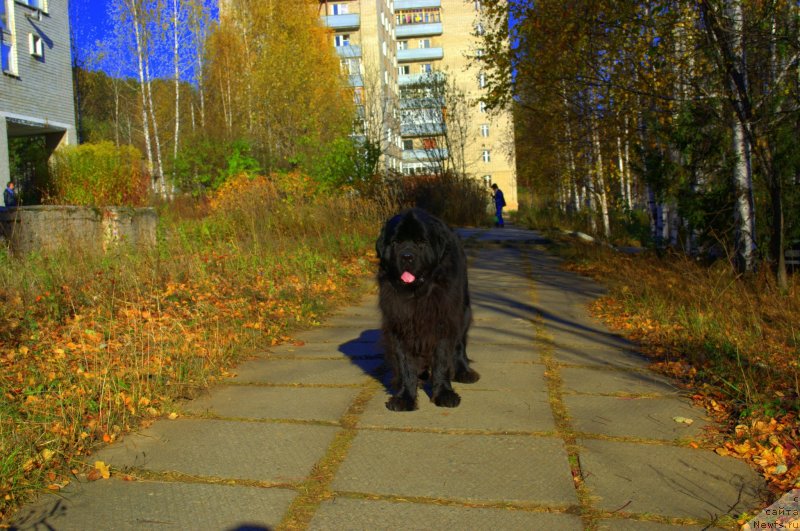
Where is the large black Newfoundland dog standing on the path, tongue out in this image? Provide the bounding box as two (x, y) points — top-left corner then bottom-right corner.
(375, 208), (480, 411)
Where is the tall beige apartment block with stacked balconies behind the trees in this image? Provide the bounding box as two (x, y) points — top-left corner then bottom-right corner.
(320, 0), (518, 209)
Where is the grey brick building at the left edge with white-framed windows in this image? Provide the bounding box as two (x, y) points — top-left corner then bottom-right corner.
(0, 0), (77, 197)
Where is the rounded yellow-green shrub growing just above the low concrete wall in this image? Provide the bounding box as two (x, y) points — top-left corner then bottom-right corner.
(45, 142), (149, 206)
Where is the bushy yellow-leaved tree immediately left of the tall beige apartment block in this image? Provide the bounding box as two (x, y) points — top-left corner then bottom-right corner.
(206, 0), (354, 174)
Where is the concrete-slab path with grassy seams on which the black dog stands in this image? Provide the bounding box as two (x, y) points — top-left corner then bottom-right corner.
(9, 227), (763, 530)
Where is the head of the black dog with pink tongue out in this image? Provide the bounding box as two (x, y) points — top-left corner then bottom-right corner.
(375, 209), (447, 289)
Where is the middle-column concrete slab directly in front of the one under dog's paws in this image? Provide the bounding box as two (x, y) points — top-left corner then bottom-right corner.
(331, 430), (578, 507)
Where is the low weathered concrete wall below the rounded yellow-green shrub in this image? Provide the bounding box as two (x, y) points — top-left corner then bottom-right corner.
(0, 205), (158, 254)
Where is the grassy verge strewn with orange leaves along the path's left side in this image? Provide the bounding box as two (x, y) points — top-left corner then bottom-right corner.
(0, 178), (380, 519)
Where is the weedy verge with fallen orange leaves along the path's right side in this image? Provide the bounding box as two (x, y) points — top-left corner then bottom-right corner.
(555, 238), (800, 508)
